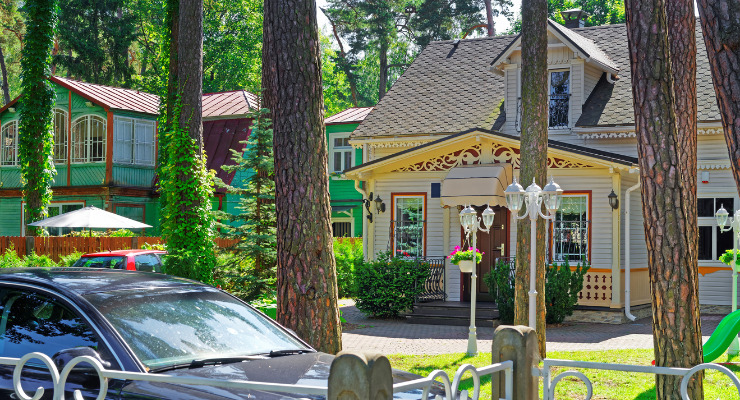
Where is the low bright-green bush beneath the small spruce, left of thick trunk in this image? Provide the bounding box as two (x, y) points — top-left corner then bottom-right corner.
(213, 252), (275, 302)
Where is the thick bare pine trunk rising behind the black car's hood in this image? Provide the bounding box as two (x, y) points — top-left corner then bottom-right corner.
(262, 0), (342, 353)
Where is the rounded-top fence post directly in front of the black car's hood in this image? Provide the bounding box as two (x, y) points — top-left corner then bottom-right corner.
(327, 352), (393, 400)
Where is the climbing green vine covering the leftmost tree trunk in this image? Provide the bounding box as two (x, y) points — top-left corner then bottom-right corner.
(18, 0), (57, 235)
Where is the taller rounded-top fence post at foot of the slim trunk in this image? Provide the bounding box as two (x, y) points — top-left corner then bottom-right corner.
(491, 325), (540, 400)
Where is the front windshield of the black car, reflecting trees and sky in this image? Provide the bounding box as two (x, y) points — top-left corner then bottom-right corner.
(85, 288), (310, 369)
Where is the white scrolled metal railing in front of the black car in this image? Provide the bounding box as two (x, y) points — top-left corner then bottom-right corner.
(0, 353), (514, 400)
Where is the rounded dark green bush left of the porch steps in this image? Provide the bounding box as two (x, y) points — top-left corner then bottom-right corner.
(355, 252), (429, 317)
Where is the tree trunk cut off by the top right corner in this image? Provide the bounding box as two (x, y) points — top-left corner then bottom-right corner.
(697, 0), (740, 195)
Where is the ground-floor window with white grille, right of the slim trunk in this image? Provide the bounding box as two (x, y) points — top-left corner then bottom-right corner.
(552, 195), (590, 265)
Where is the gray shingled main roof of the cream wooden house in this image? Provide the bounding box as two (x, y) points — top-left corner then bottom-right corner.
(352, 23), (720, 137)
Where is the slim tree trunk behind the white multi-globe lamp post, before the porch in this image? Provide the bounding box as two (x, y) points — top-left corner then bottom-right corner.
(514, 0), (549, 357)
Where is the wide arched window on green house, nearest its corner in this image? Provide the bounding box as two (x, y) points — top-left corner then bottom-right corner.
(72, 115), (106, 163)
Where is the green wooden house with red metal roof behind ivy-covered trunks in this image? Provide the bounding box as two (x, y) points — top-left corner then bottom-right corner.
(0, 76), (257, 236)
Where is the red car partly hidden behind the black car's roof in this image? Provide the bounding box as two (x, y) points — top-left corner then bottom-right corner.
(72, 249), (167, 272)
